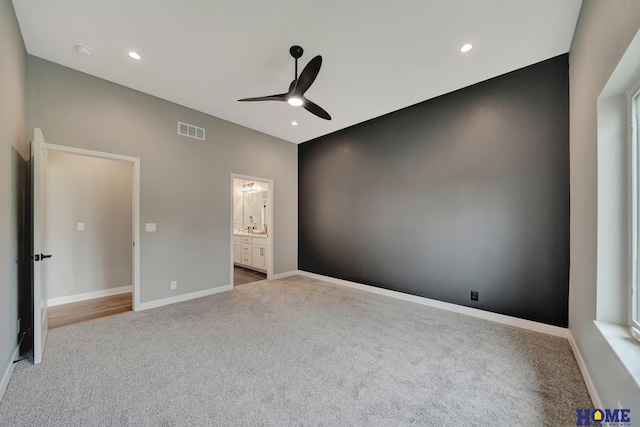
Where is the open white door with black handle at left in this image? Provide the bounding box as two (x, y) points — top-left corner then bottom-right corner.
(31, 128), (51, 364)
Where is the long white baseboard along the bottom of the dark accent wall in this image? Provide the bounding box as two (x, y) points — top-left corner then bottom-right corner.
(294, 270), (569, 338)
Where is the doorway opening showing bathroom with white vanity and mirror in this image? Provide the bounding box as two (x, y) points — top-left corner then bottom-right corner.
(231, 174), (273, 286)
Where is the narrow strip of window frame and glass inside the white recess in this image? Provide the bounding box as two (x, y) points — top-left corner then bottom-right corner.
(629, 80), (640, 341)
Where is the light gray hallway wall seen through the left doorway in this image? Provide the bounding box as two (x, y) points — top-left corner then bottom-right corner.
(47, 151), (133, 298)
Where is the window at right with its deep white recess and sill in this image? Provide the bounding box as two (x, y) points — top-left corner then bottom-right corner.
(596, 26), (640, 390)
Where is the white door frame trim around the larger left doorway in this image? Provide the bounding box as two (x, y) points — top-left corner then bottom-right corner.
(46, 144), (141, 311)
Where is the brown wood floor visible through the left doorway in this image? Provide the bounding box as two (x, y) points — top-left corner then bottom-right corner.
(48, 292), (132, 329)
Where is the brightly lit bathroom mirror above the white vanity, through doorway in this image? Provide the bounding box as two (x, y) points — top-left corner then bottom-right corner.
(233, 178), (269, 234)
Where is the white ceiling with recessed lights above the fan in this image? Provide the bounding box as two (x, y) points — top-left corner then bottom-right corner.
(13, 0), (582, 143)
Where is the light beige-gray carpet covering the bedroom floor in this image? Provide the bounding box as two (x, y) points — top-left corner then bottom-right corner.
(0, 276), (591, 426)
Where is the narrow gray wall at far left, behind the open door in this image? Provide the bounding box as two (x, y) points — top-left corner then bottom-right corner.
(0, 0), (28, 392)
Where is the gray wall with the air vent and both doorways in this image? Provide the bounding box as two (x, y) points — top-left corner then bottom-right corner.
(27, 56), (298, 302)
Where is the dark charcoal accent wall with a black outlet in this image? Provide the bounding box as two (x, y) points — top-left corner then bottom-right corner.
(298, 55), (569, 327)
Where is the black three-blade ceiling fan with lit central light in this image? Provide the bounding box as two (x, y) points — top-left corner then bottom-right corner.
(238, 46), (331, 120)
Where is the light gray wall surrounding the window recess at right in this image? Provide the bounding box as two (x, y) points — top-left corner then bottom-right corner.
(569, 0), (640, 419)
